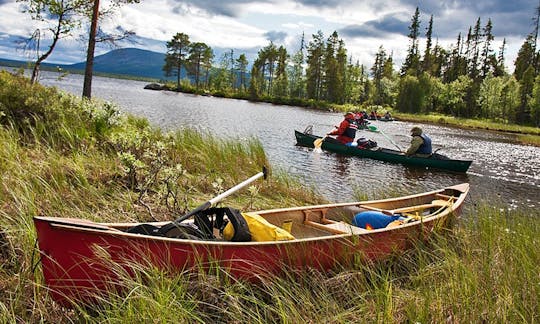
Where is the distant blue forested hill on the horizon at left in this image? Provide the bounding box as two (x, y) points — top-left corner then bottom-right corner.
(0, 48), (177, 80)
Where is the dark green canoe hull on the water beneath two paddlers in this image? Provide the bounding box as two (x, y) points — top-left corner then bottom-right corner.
(294, 130), (472, 172)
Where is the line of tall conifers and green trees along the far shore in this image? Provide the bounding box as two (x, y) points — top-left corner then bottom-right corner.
(163, 8), (540, 127)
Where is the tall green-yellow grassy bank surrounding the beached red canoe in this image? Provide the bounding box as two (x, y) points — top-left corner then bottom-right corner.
(0, 72), (540, 323)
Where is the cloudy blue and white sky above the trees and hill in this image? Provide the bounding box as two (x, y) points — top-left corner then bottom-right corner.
(0, 0), (540, 73)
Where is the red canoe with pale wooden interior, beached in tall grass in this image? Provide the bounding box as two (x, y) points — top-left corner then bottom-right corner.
(34, 183), (469, 306)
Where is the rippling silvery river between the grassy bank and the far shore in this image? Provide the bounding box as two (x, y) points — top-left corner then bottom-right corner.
(28, 72), (540, 209)
